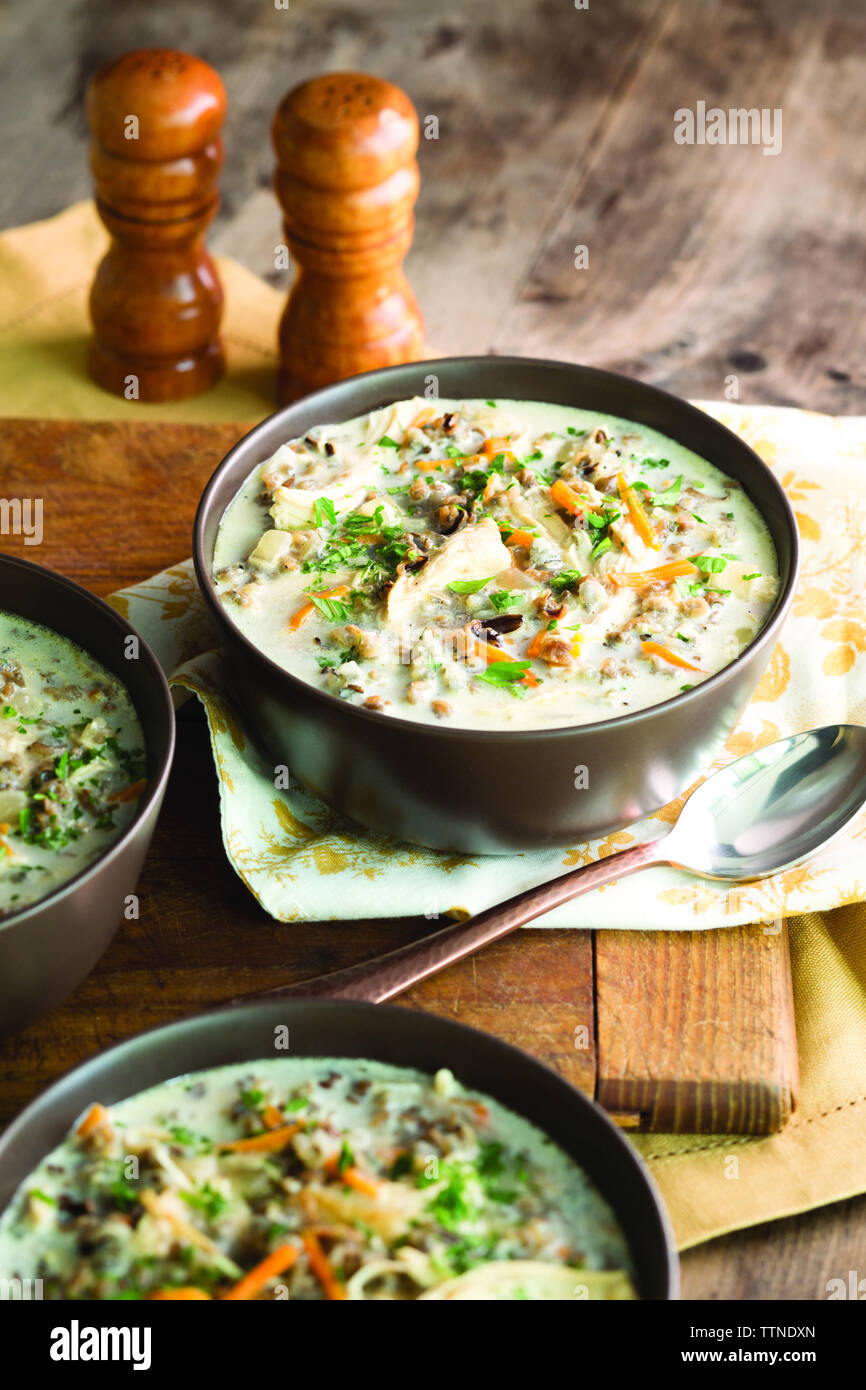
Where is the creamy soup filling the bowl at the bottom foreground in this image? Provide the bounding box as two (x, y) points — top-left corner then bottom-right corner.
(0, 1058), (635, 1301)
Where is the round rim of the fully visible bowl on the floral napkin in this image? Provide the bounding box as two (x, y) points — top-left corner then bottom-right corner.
(193, 354), (801, 745)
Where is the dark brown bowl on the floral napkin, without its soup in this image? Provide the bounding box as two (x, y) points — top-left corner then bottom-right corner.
(195, 357), (799, 853)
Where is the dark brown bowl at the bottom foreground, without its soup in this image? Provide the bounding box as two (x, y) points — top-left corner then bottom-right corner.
(0, 999), (678, 1298)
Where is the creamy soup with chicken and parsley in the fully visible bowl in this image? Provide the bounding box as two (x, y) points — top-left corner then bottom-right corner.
(214, 399), (778, 730)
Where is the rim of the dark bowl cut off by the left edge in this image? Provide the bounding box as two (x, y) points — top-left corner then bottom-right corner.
(0, 550), (177, 937)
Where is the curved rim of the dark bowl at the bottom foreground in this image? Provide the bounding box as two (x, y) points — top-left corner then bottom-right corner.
(0, 995), (680, 1301)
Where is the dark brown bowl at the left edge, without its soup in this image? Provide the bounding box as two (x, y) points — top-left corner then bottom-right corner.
(0, 555), (174, 1034)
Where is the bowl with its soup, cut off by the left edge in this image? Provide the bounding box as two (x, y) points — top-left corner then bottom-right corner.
(0, 556), (174, 1033)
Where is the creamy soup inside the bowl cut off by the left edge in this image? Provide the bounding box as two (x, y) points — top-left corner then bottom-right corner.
(0, 612), (146, 916)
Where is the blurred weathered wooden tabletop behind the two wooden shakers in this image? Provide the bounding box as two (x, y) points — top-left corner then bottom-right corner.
(0, 0), (866, 414)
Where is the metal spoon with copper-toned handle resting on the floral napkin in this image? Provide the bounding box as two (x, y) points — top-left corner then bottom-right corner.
(248, 724), (866, 1004)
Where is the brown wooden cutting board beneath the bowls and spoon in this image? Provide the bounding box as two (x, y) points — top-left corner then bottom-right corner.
(0, 420), (798, 1134)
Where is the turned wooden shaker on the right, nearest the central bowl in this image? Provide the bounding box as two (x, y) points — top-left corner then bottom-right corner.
(272, 72), (424, 400)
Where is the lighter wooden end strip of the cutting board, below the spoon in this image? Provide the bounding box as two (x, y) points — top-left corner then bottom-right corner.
(595, 922), (799, 1134)
